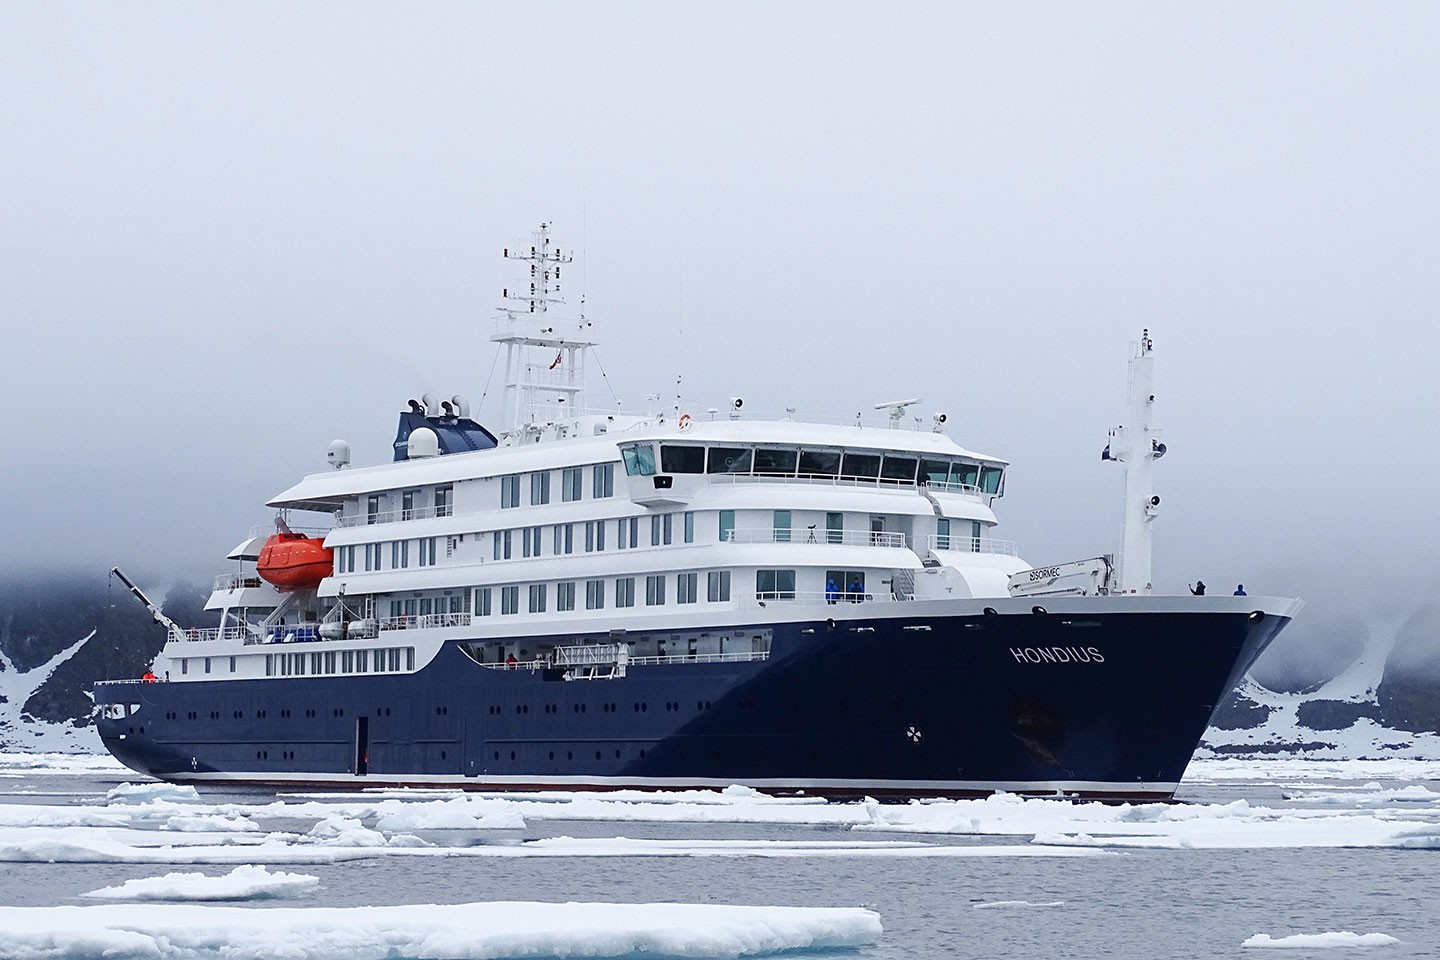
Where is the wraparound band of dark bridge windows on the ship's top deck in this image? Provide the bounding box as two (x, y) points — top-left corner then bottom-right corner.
(621, 443), (1005, 497)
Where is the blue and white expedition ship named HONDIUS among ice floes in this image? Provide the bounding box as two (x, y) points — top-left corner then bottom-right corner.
(95, 226), (1300, 799)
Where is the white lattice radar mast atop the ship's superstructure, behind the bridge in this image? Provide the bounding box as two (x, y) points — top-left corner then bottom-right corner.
(490, 223), (595, 435)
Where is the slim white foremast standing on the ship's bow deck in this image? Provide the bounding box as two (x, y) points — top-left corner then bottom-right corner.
(1100, 330), (1165, 593)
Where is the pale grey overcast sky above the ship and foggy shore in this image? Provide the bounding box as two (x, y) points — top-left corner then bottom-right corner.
(0, 0), (1440, 639)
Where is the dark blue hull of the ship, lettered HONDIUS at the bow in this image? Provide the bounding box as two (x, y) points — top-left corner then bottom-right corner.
(95, 599), (1289, 799)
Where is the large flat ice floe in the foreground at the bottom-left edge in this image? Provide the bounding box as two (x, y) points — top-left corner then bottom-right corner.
(0, 902), (881, 960)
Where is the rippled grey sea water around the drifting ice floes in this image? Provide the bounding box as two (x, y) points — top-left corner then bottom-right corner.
(0, 761), (1440, 960)
